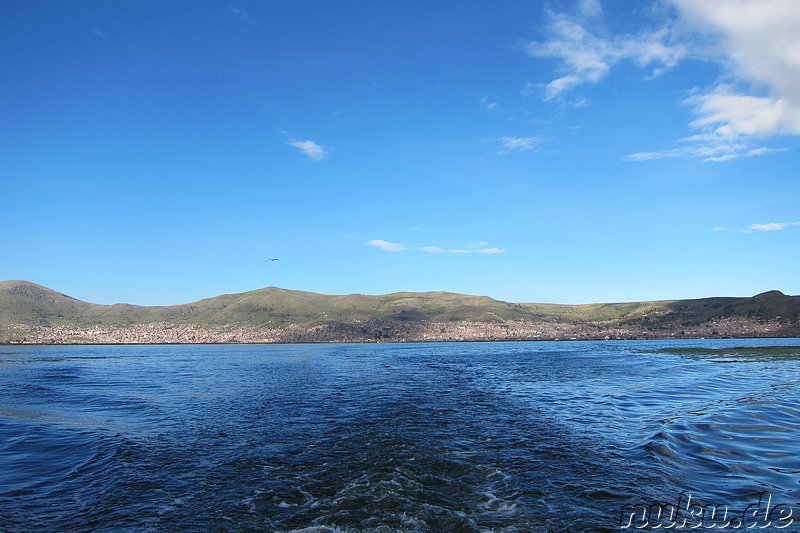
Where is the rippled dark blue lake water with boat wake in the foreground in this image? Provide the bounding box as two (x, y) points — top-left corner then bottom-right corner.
(0, 339), (800, 533)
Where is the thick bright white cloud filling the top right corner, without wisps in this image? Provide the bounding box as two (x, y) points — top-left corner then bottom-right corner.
(660, 0), (800, 161)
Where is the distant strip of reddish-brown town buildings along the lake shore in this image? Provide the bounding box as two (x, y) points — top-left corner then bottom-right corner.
(4, 317), (800, 344)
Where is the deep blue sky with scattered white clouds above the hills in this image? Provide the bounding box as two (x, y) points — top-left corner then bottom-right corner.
(0, 0), (800, 305)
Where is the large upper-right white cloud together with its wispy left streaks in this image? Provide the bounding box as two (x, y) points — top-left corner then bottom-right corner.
(526, 0), (800, 162)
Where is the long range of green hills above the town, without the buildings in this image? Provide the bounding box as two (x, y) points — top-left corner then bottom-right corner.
(0, 281), (800, 328)
